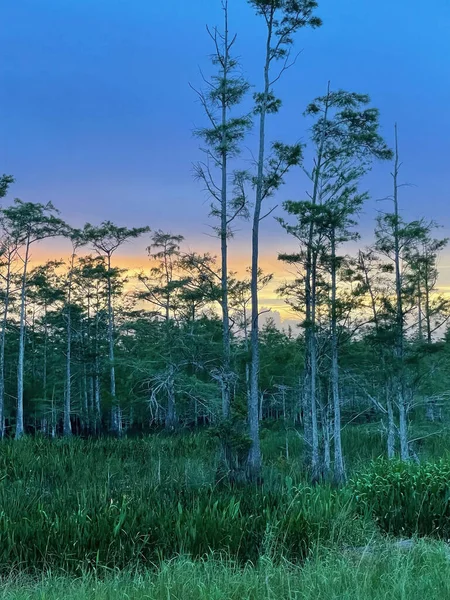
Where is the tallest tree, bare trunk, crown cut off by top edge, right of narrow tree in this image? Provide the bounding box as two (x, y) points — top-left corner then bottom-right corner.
(248, 0), (322, 480)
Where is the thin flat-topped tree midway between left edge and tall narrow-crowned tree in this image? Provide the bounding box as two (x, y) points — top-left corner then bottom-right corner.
(83, 221), (149, 436)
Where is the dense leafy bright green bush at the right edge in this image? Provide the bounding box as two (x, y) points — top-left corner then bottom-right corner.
(350, 460), (450, 539)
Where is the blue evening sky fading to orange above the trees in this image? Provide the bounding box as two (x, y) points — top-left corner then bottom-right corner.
(0, 0), (450, 318)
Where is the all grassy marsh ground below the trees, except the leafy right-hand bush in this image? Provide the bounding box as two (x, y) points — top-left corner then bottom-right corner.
(0, 423), (450, 600)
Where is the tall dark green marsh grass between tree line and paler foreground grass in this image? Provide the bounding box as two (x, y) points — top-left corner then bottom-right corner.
(0, 424), (450, 584)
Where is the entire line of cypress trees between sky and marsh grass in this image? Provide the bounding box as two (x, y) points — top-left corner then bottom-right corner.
(0, 0), (450, 484)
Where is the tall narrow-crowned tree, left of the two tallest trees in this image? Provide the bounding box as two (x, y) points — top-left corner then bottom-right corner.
(192, 0), (252, 432)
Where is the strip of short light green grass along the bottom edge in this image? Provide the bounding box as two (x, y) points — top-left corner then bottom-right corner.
(0, 542), (450, 600)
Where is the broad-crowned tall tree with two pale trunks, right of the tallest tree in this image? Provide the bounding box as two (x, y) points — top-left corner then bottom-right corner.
(280, 85), (391, 484)
